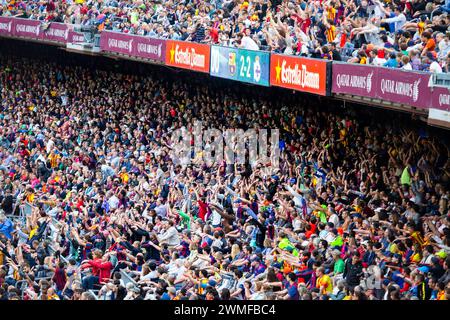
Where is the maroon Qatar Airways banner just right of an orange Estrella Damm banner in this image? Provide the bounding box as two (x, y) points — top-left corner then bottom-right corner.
(332, 63), (432, 108)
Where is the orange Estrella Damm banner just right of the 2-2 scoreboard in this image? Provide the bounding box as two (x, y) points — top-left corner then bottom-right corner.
(270, 54), (330, 95)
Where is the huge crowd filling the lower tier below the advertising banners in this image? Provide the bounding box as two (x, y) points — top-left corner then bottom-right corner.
(0, 51), (450, 300)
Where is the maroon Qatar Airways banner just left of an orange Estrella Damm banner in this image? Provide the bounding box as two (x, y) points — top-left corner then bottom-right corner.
(100, 31), (166, 62)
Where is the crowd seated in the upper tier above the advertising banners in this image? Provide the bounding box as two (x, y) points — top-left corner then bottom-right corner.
(0, 0), (450, 72)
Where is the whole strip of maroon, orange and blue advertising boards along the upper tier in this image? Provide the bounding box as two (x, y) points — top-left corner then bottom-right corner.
(0, 17), (450, 111)
